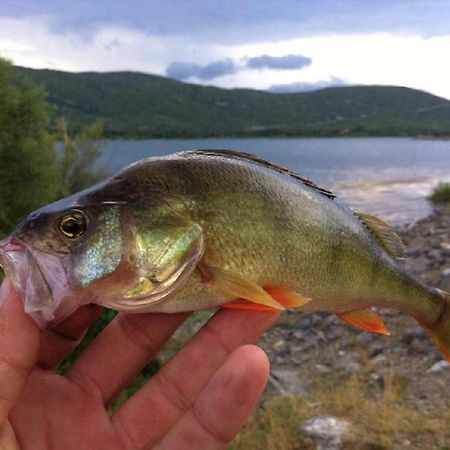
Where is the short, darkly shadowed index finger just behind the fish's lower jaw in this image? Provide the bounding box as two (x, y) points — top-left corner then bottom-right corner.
(38, 304), (102, 369)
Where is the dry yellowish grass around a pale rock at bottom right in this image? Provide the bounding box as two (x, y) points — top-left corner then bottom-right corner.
(229, 370), (450, 450)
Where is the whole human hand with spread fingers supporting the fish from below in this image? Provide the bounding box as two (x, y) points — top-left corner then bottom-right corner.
(0, 280), (277, 450)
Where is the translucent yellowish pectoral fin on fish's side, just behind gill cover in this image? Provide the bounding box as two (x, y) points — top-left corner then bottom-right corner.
(197, 263), (285, 309)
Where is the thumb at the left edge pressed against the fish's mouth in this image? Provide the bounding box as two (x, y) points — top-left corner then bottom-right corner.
(0, 279), (39, 424)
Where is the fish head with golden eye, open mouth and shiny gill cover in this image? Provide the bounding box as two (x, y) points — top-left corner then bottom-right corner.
(0, 200), (203, 326)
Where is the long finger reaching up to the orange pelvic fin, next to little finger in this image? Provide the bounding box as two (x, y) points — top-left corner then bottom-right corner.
(113, 310), (278, 448)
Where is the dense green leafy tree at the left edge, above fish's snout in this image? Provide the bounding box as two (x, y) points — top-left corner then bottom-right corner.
(0, 58), (58, 236)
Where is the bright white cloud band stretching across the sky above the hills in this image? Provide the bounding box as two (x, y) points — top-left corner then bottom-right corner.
(0, 17), (450, 99)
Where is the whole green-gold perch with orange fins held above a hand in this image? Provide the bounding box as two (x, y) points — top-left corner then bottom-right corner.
(0, 150), (450, 361)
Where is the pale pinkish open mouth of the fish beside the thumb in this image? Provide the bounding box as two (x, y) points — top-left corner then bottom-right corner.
(0, 237), (74, 327)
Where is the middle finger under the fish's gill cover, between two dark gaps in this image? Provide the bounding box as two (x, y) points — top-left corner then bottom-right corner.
(66, 313), (187, 404)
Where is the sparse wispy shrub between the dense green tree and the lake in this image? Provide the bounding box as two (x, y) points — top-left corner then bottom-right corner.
(56, 119), (106, 197)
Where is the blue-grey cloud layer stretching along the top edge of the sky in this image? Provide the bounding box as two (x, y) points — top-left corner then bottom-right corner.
(0, 0), (450, 43)
